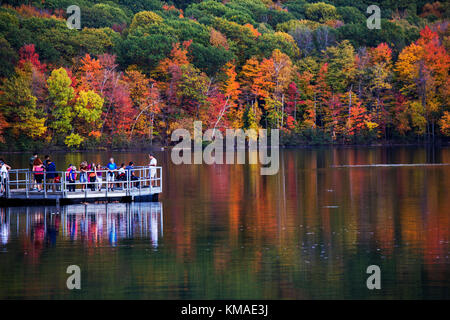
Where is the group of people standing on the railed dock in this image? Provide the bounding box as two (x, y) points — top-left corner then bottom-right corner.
(0, 153), (157, 193)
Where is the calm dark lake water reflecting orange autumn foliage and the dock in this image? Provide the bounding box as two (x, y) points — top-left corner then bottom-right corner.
(0, 147), (450, 299)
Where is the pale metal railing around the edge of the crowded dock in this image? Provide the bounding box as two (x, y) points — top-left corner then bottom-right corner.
(2, 166), (162, 198)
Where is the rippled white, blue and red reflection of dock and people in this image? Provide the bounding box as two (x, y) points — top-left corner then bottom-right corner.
(0, 202), (163, 248)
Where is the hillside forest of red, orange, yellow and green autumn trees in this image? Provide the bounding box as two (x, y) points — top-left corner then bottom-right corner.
(0, 0), (450, 151)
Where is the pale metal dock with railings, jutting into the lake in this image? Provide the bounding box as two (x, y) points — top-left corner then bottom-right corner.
(0, 167), (162, 206)
